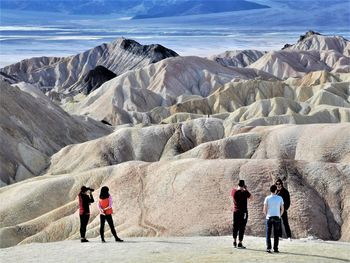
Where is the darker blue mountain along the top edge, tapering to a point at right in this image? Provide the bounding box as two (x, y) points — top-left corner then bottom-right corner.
(1, 0), (268, 19)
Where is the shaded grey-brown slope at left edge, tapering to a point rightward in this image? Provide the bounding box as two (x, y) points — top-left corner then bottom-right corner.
(0, 82), (111, 186)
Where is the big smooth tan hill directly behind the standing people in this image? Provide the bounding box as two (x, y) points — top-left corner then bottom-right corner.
(0, 159), (350, 250)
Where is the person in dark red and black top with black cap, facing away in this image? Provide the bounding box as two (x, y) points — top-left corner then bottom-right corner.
(231, 180), (252, 248)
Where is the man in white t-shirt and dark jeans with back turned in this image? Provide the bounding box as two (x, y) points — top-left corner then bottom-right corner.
(264, 185), (284, 253)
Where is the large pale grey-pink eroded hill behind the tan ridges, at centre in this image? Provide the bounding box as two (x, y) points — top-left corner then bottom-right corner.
(71, 57), (274, 125)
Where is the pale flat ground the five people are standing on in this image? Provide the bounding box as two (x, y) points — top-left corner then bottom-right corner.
(0, 236), (350, 263)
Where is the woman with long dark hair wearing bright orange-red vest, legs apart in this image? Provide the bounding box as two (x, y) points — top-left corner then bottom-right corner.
(98, 186), (123, 243)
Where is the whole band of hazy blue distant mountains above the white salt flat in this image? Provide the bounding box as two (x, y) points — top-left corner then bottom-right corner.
(0, 0), (350, 31)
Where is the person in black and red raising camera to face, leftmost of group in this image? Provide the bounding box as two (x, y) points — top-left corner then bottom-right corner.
(78, 185), (94, 242)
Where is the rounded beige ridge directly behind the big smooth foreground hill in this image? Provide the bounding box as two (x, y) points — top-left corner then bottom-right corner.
(48, 122), (350, 174)
